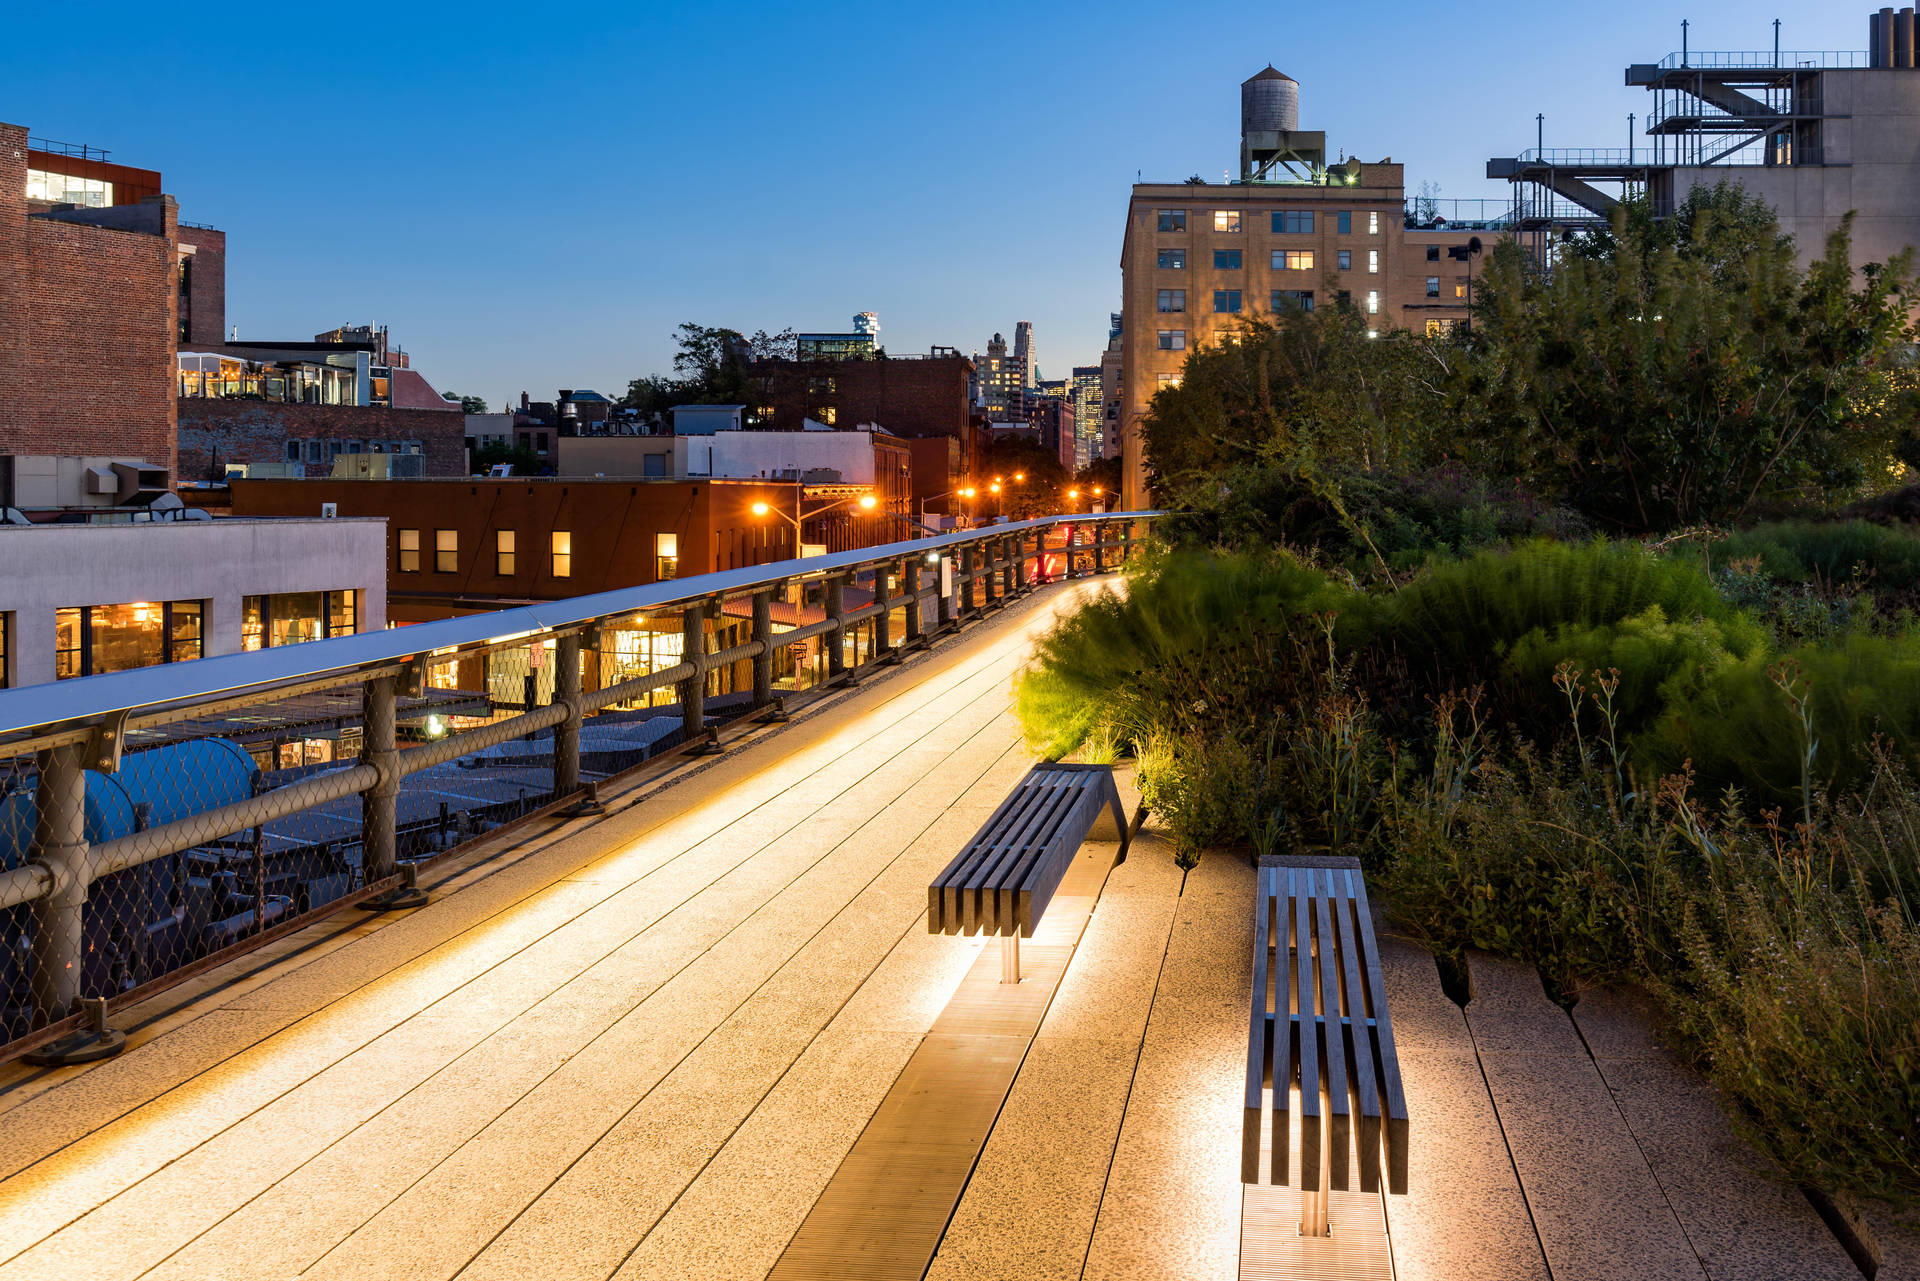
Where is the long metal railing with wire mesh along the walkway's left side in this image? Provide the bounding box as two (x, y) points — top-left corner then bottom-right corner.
(0, 513), (1158, 1060)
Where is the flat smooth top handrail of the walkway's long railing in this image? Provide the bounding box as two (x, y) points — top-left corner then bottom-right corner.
(0, 511), (1160, 753)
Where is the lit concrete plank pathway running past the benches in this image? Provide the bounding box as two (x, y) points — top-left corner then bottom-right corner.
(0, 586), (1889, 1281)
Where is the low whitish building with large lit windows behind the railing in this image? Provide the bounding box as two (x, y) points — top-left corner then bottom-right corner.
(0, 507), (386, 688)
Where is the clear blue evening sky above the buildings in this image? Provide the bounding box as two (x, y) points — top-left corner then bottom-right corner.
(0, 0), (1876, 407)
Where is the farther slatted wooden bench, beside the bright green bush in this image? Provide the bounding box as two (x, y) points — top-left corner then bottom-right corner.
(927, 764), (1127, 983)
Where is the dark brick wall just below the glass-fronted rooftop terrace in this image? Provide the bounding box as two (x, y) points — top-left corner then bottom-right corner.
(179, 396), (467, 480)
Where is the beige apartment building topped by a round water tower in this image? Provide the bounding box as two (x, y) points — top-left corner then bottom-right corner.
(1119, 67), (1501, 509)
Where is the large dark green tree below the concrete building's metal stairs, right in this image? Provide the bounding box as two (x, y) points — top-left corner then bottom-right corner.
(1455, 204), (1920, 534)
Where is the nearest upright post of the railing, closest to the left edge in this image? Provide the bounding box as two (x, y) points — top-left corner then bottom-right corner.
(33, 743), (92, 1024)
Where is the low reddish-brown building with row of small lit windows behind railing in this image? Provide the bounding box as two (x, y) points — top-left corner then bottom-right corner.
(230, 478), (797, 622)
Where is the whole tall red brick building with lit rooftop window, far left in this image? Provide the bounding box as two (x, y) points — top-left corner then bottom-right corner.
(0, 123), (192, 507)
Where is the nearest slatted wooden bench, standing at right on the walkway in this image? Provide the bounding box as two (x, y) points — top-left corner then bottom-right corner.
(1240, 857), (1407, 1237)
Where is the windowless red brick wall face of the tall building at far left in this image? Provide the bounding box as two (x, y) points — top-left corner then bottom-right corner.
(0, 125), (177, 472)
